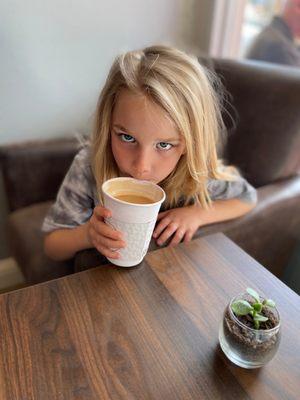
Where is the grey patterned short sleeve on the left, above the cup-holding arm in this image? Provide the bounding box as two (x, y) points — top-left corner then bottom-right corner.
(42, 146), (95, 233)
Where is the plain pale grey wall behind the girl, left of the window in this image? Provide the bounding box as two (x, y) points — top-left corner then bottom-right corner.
(0, 0), (213, 256)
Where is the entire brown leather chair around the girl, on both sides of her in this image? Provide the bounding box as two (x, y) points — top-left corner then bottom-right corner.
(0, 59), (300, 283)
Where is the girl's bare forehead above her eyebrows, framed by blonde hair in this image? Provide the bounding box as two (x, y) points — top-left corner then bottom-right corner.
(112, 89), (180, 137)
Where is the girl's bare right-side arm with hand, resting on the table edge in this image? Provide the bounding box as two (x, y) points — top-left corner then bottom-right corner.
(153, 199), (255, 246)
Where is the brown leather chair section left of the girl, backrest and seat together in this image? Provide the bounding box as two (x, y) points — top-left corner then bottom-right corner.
(0, 138), (78, 284)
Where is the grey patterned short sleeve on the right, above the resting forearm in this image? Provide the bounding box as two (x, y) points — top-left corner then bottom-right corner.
(207, 176), (257, 204)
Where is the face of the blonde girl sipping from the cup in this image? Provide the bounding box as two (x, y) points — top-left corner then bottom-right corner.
(111, 89), (185, 183)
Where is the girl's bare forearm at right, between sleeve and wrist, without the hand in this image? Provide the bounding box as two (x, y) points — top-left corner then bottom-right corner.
(200, 199), (255, 225)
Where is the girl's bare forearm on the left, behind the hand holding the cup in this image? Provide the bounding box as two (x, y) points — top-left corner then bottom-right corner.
(44, 224), (92, 261)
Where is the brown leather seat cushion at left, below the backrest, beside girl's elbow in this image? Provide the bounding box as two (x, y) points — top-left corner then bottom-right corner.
(7, 201), (73, 284)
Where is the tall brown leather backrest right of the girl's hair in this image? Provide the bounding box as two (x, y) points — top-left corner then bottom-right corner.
(200, 59), (300, 187)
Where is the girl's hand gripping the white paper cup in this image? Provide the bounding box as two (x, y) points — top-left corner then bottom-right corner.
(87, 206), (126, 259)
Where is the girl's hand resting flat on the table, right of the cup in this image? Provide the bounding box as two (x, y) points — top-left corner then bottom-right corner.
(153, 206), (203, 246)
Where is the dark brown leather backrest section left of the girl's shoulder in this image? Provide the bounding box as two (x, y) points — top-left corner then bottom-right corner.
(0, 138), (79, 211)
